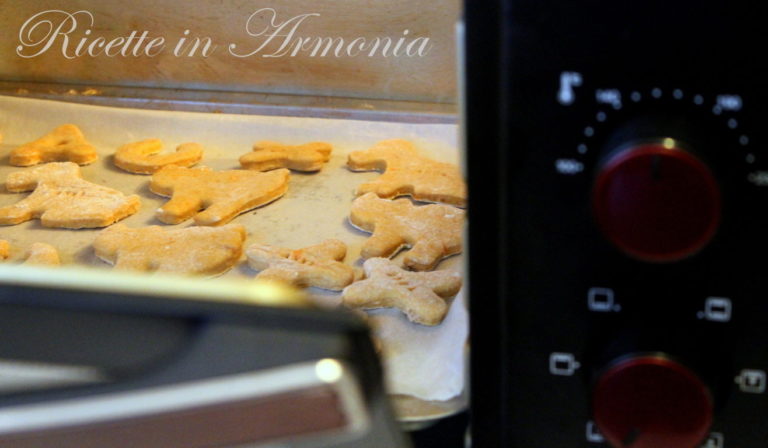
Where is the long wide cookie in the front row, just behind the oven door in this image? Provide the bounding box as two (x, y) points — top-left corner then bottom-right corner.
(93, 224), (246, 275)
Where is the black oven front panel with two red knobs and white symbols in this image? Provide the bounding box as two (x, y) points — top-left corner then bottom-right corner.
(464, 0), (768, 448)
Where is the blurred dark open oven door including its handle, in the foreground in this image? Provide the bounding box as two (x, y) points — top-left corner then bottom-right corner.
(0, 267), (381, 448)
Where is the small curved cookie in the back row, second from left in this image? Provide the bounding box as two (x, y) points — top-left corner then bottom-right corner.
(114, 138), (203, 174)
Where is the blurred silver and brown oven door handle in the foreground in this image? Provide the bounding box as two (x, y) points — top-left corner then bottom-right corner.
(0, 359), (370, 448)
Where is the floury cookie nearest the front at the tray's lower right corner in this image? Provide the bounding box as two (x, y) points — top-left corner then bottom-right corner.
(342, 258), (461, 325)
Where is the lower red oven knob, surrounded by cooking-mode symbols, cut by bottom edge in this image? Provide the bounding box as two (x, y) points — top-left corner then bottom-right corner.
(592, 355), (713, 448)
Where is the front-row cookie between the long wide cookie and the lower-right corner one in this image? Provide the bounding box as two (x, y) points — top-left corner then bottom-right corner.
(245, 240), (355, 291)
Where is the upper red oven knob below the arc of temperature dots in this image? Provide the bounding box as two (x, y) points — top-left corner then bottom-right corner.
(592, 139), (721, 262)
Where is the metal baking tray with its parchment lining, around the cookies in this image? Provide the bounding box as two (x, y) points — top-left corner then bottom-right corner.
(0, 88), (468, 428)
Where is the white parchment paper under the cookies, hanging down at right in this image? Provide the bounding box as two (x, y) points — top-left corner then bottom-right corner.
(0, 97), (468, 400)
